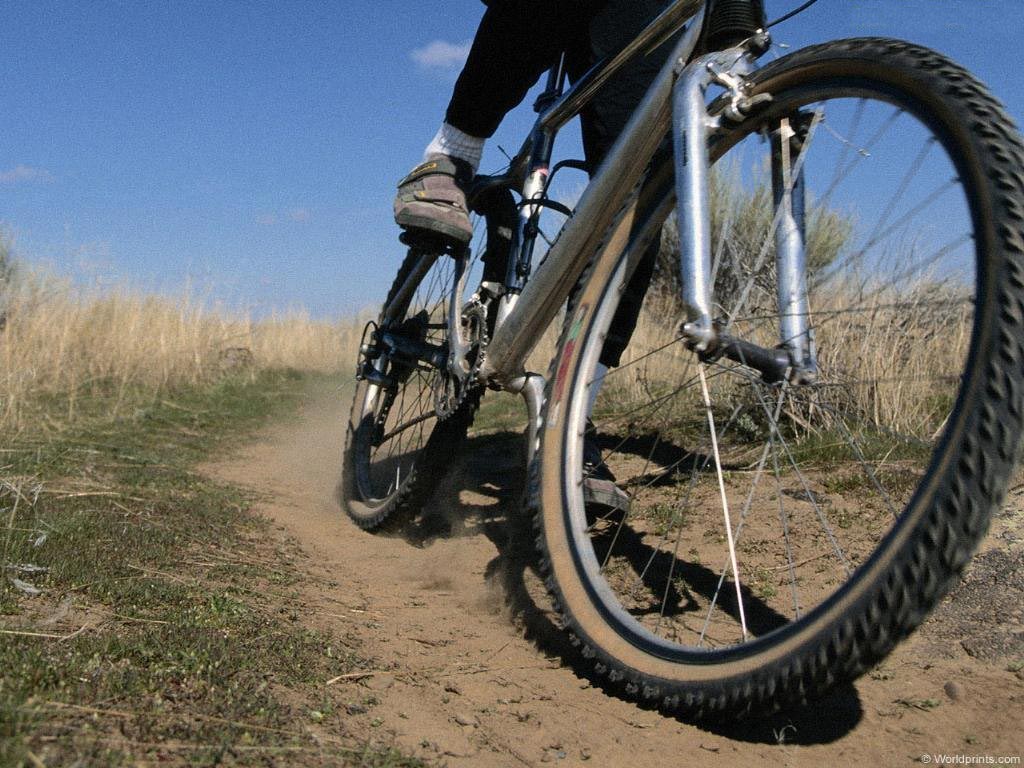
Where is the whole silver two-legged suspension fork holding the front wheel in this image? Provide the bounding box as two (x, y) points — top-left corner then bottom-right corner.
(672, 34), (816, 382)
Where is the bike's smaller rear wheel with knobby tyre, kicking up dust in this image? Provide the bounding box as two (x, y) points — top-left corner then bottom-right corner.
(340, 248), (480, 529)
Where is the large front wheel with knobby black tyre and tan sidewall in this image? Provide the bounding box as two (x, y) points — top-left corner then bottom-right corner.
(531, 39), (1024, 718)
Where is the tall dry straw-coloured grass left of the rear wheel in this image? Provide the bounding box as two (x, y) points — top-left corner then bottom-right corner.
(0, 272), (361, 430)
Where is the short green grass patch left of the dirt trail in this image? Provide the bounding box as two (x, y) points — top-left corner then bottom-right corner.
(0, 371), (422, 766)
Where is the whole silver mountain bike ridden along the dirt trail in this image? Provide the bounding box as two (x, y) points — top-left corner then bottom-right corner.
(342, 0), (1024, 719)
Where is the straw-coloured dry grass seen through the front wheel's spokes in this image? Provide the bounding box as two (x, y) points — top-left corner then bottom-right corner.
(598, 281), (973, 441)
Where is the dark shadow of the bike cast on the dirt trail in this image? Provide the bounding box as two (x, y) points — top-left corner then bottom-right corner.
(401, 432), (864, 745)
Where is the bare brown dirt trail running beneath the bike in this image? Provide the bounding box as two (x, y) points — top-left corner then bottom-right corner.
(211, 392), (1024, 766)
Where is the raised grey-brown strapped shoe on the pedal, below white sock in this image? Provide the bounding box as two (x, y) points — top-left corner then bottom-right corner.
(394, 155), (473, 245)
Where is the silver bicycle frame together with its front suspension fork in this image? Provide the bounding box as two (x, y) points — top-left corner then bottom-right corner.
(384, 0), (802, 434)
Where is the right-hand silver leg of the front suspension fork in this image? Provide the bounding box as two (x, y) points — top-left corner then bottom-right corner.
(771, 118), (816, 379)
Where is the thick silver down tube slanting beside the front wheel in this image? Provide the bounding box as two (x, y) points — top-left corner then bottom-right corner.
(480, 7), (703, 385)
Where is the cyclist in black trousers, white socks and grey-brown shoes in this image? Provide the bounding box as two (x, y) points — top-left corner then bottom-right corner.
(394, 0), (673, 507)
